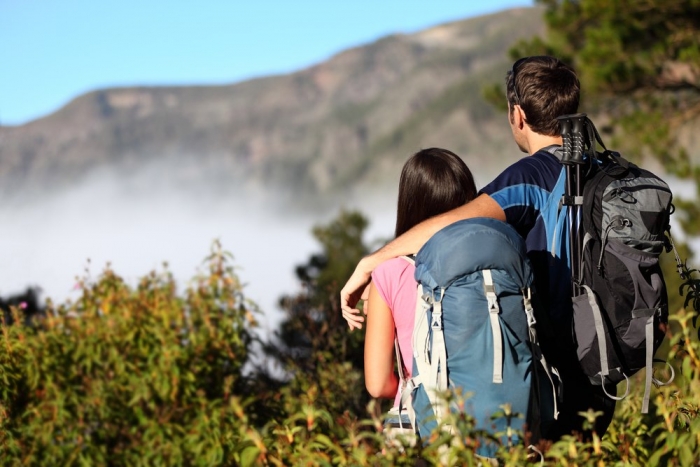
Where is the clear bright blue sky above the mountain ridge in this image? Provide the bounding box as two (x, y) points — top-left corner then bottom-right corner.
(0, 0), (534, 125)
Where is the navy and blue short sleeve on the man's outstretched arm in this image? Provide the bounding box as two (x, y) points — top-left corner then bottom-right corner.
(479, 156), (549, 236)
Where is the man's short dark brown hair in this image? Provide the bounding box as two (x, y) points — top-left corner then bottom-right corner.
(506, 56), (581, 136)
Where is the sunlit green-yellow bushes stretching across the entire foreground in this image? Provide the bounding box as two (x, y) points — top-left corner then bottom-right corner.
(0, 241), (700, 466)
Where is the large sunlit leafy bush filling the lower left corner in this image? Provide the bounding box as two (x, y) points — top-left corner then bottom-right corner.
(0, 244), (255, 465)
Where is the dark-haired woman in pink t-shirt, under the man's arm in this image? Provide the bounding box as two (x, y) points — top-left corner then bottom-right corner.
(365, 148), (476, 427)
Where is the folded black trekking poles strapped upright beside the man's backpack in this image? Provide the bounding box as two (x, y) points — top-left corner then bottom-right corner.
(557, 113), (587, 297)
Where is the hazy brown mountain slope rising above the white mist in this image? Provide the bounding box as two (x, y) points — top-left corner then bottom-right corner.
(0, 8), (544, 207)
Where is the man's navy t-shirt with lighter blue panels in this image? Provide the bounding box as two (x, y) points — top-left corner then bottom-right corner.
(479, 146), (572, 331)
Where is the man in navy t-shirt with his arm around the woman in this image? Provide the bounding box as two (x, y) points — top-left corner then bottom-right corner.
(340, 56), (615, 439)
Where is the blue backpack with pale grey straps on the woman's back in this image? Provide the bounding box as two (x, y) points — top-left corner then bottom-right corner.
(402, 218), (557, 457)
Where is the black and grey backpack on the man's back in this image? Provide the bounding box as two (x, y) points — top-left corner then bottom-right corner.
(562, 115), (673, 413)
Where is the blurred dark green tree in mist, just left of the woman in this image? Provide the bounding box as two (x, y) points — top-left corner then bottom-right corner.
(266, 211), (368, 416)
